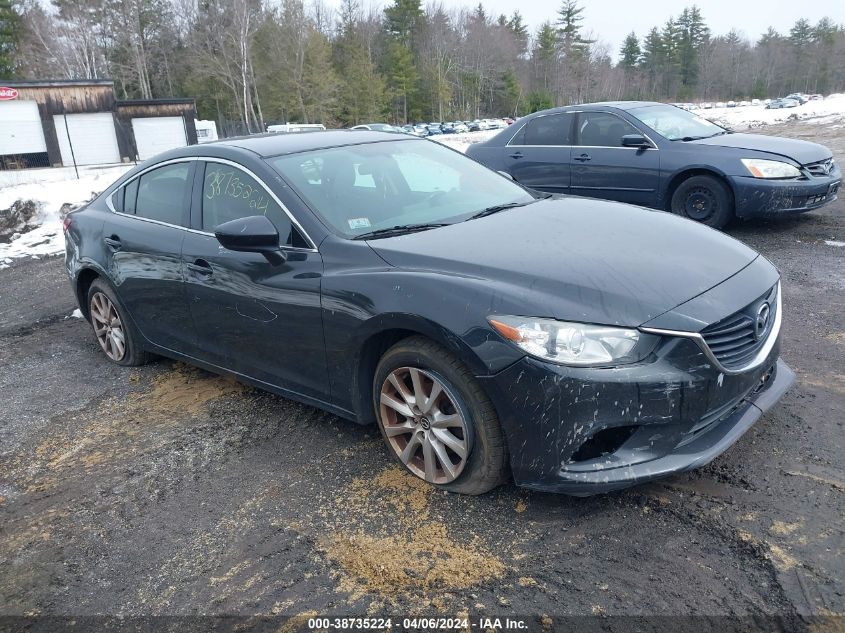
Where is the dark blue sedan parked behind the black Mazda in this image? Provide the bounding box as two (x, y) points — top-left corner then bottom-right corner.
(467, 101), (842, 228)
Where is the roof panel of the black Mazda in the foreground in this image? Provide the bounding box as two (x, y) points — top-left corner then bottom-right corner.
(197, 130), (416, 158)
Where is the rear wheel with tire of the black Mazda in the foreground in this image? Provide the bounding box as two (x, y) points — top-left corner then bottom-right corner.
(88, 279), (150, 367)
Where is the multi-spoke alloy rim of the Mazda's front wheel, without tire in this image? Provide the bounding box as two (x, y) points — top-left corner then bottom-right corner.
(379, 367), (472, 484)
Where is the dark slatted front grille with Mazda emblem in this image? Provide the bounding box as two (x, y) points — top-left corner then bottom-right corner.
(701, 284), (778, 369)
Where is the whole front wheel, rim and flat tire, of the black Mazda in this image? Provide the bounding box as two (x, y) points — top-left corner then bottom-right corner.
(373, 336), (508, 495)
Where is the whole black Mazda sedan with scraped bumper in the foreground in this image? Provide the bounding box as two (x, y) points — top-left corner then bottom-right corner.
(65, 131), (793, 495)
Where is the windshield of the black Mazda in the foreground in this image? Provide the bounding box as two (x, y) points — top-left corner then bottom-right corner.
(268, 139), (534, 239)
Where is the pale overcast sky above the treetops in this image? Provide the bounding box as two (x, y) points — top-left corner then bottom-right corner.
(327, 0), (845, 58)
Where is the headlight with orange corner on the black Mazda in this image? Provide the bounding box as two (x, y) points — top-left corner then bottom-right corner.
(488, 315), (659, 367)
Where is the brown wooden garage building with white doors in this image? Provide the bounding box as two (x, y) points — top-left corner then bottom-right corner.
(0, 79), (197, 169)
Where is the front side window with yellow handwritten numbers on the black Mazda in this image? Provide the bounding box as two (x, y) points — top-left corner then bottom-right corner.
(202, 163), (304, 246)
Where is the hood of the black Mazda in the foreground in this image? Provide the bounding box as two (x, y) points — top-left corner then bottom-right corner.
(369, 197), (762, 327)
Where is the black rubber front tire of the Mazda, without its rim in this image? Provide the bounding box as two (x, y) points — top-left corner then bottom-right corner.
(373, 336), (509, 495)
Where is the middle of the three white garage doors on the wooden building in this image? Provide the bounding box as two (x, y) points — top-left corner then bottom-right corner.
(53, 112), (120, 166)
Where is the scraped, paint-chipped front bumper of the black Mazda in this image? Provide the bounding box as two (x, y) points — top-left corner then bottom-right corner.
(479, 338), (795, 496)
